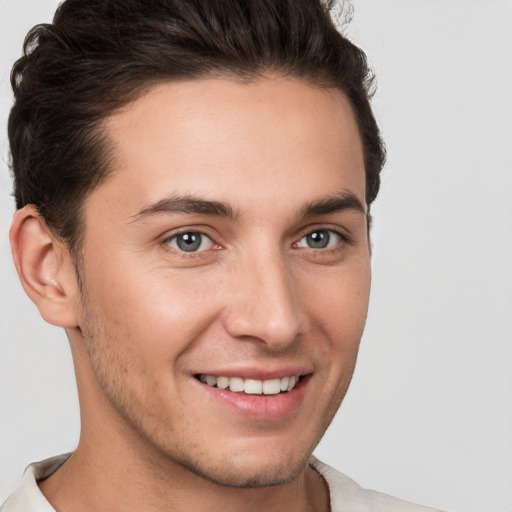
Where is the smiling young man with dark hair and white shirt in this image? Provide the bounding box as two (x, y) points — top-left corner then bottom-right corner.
(2, 0), (444, 512)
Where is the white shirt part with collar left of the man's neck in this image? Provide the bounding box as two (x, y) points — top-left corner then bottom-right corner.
(0, 454), (69, 512)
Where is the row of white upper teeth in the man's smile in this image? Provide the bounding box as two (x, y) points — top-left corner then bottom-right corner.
(198, 374), (299, 395)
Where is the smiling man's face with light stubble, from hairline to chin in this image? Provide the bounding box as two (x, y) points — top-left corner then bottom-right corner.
(70, 79), (370, 486)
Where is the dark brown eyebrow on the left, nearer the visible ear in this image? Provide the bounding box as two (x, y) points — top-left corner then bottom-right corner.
(129, 195), (239, 222)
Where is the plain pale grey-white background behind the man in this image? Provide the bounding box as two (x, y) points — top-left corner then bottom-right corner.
(0, 0), (512, 512)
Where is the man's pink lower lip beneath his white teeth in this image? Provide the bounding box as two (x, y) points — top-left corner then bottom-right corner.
(194, 375), (311, 420)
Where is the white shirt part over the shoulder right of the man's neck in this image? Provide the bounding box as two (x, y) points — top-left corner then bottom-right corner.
(310, 457), (441, 512)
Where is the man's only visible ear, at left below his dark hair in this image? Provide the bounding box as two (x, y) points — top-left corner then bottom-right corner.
(10, 205), (79, 328)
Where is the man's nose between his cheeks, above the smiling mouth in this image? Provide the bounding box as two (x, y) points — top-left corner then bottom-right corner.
(225, 250), (307, 350)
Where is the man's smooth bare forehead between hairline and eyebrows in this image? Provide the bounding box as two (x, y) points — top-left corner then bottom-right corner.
(93, 78), (365, 215)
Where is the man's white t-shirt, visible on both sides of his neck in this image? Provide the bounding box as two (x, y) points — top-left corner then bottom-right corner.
(0, 454), (441, 512)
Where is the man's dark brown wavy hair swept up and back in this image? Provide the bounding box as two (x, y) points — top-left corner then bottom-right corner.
(8, 0), (385, 254)
